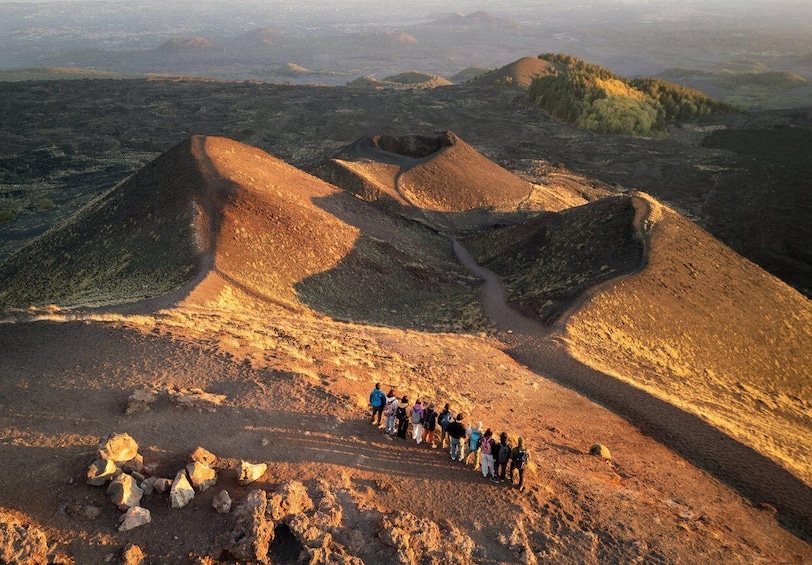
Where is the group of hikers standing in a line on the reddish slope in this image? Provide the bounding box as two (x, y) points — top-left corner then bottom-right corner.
(369, 383), (530, 491)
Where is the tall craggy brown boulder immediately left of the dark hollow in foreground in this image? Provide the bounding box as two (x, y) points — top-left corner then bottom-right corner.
(225, 489), (274, 563)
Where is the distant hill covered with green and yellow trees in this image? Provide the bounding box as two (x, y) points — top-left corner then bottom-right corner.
(529, 53), (734, 135)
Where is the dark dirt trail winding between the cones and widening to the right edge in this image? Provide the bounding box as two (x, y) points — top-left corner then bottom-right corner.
(454, 241), (812, 541)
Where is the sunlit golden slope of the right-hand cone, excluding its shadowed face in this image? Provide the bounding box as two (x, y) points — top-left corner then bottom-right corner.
(564, 198), (812, 484)
